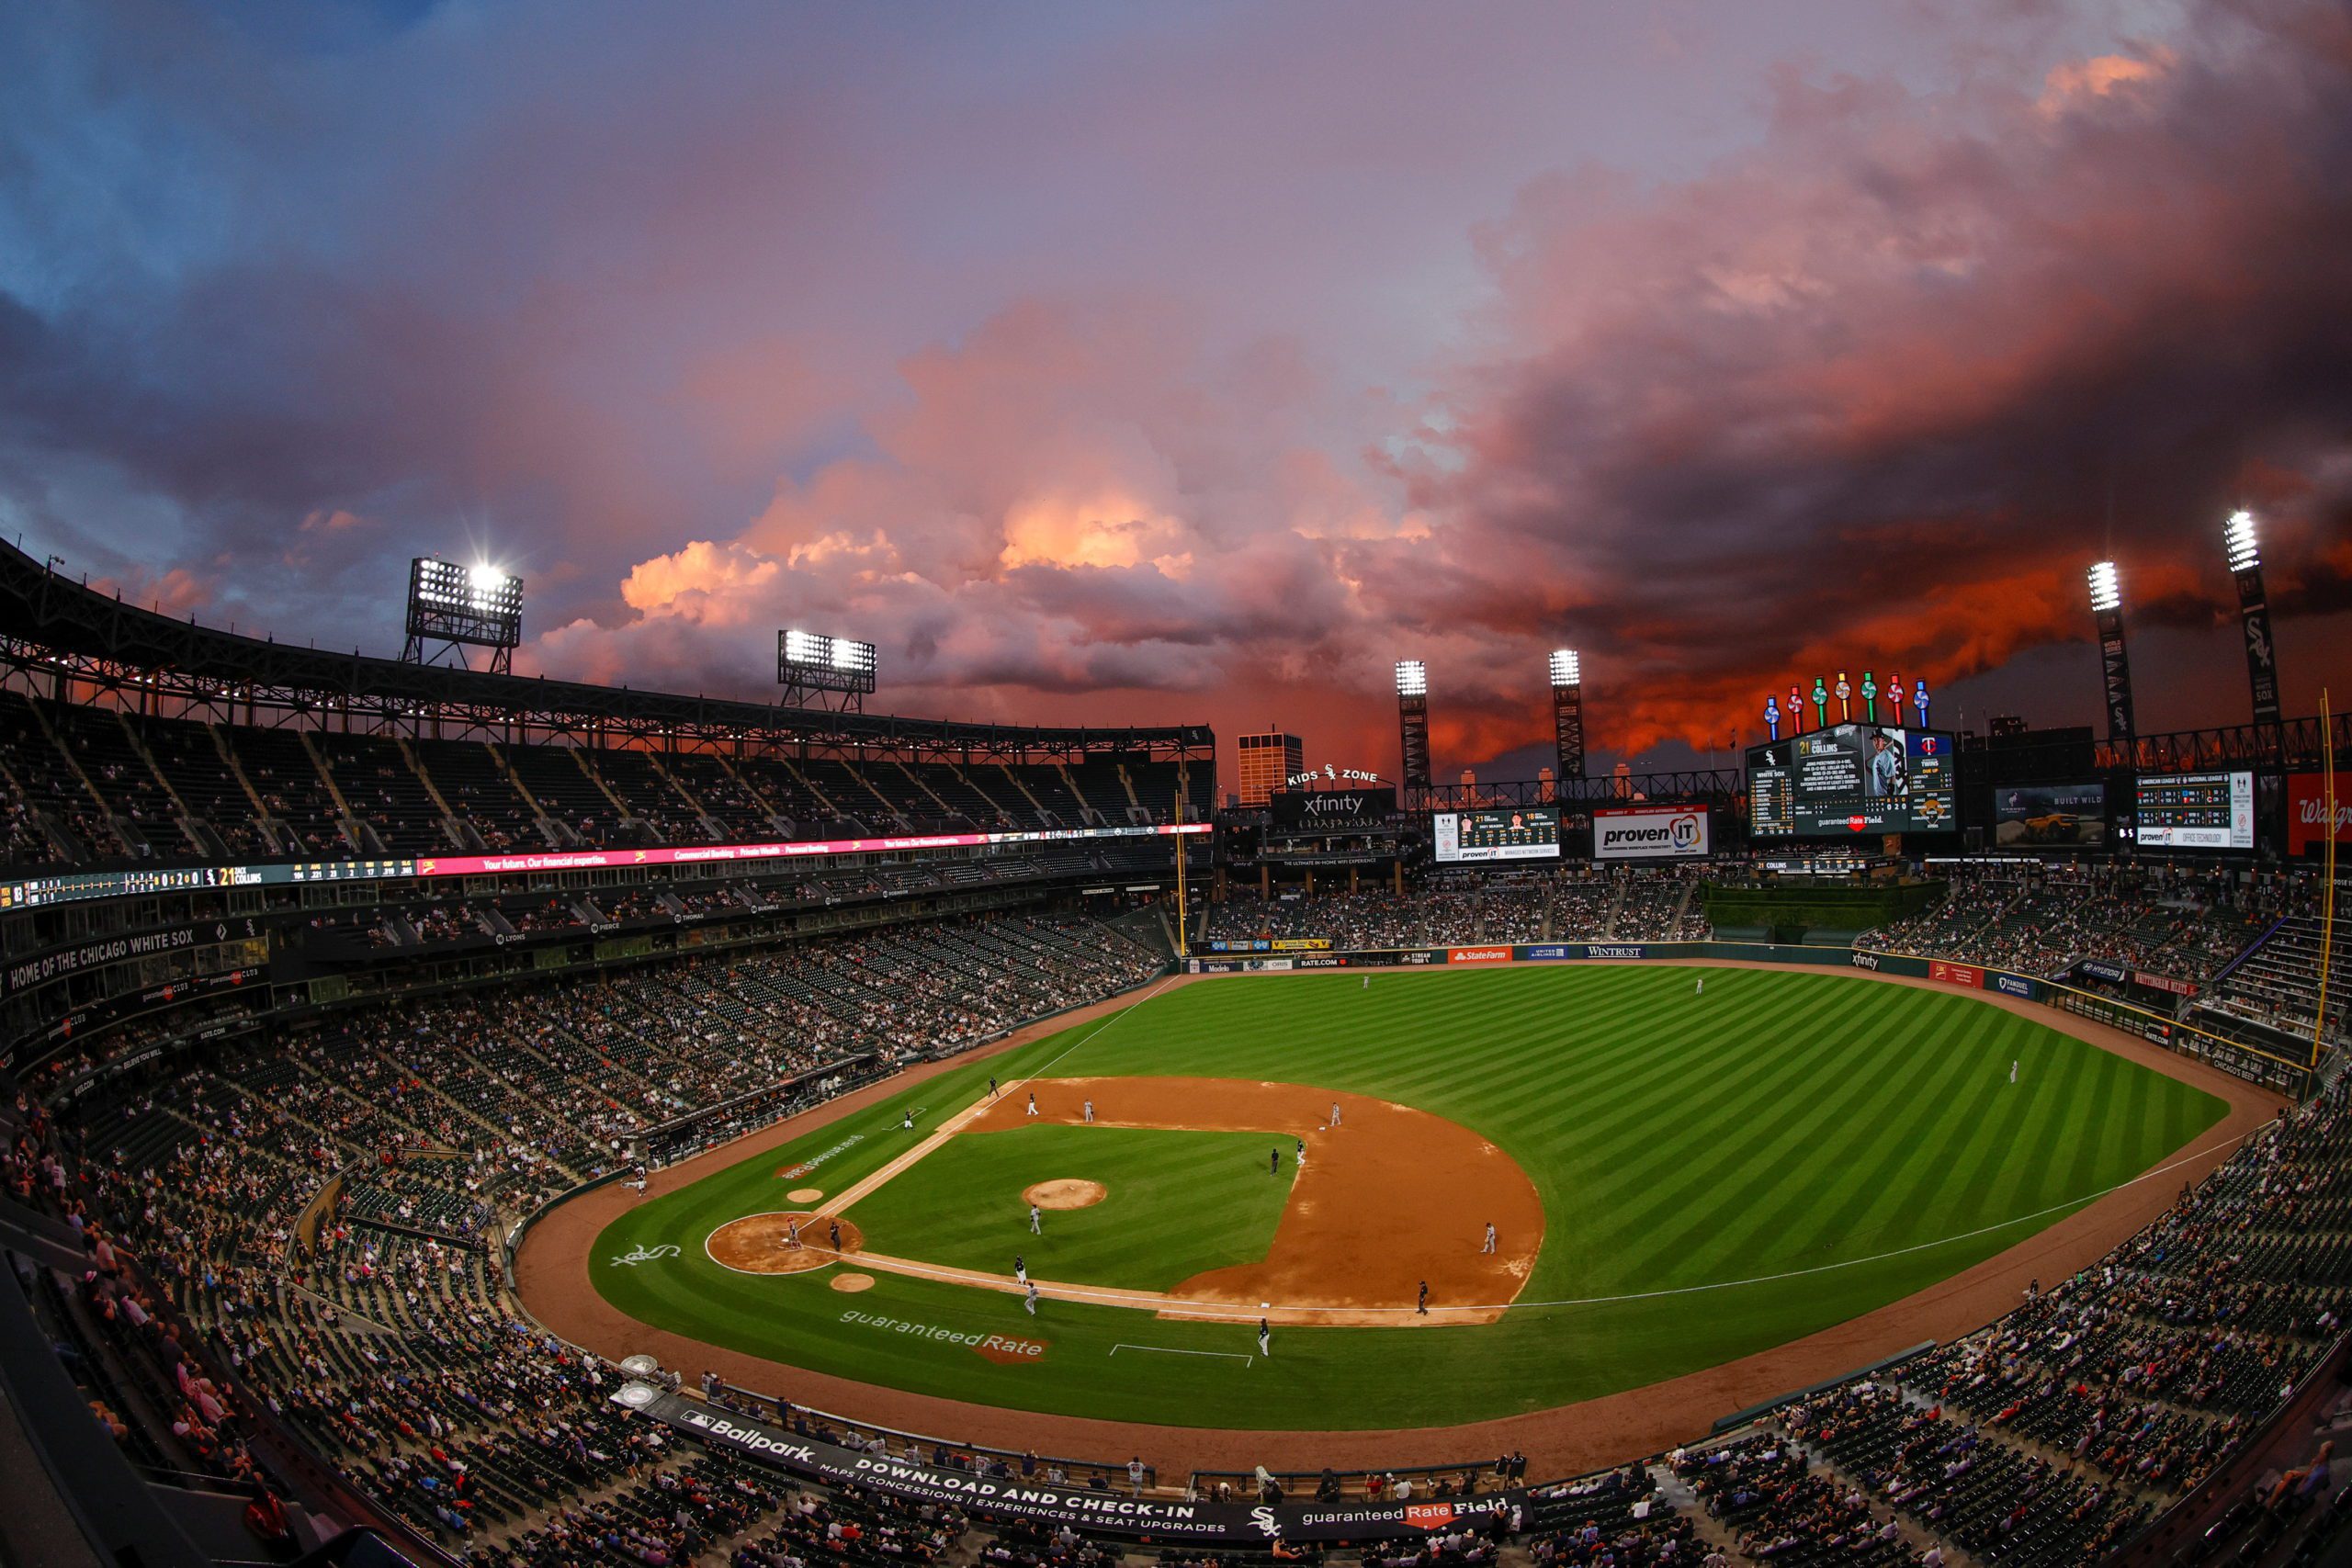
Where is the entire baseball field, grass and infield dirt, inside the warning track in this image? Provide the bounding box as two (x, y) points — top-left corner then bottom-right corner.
(591, 966), (2227, 1429)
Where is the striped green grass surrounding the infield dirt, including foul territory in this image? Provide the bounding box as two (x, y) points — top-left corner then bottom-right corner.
(591, 966), (2225, 1427)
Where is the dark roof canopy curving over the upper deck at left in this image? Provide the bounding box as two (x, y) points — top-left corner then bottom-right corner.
(0, 541), (1216, 760)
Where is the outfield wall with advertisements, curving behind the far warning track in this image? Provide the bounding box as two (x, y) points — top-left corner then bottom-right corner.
(1183, 938), (2312, 1098)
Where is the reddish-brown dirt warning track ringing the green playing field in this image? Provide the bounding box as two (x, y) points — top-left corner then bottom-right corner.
(515, 959), (2281, 1476)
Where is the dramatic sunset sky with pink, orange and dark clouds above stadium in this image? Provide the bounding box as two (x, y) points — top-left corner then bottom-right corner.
(0, 0), (2352, 776)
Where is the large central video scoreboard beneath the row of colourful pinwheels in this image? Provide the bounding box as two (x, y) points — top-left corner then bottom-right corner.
(1747, 724), (1957, 840)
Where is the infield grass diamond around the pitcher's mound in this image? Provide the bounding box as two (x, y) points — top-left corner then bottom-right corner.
(852, 1126), (1294, 1291)
